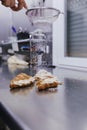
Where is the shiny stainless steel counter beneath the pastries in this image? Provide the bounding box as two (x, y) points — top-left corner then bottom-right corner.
(0, 63), (87, 130)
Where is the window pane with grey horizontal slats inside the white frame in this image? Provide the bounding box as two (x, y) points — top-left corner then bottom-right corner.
(67, 0), (87, 58)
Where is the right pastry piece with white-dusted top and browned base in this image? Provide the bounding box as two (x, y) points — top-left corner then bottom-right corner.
(35, 70), (61, 90)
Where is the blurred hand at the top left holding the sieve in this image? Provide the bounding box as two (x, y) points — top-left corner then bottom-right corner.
(1, 0), (27, 11)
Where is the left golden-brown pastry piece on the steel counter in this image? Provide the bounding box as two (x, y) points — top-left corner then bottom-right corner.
(10, 73), (35, 89)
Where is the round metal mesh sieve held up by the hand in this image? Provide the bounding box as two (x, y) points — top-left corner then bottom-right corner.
(26, 7), (61, 24)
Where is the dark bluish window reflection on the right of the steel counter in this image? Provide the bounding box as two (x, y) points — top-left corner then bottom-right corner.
(64, 78), (87, 130)
